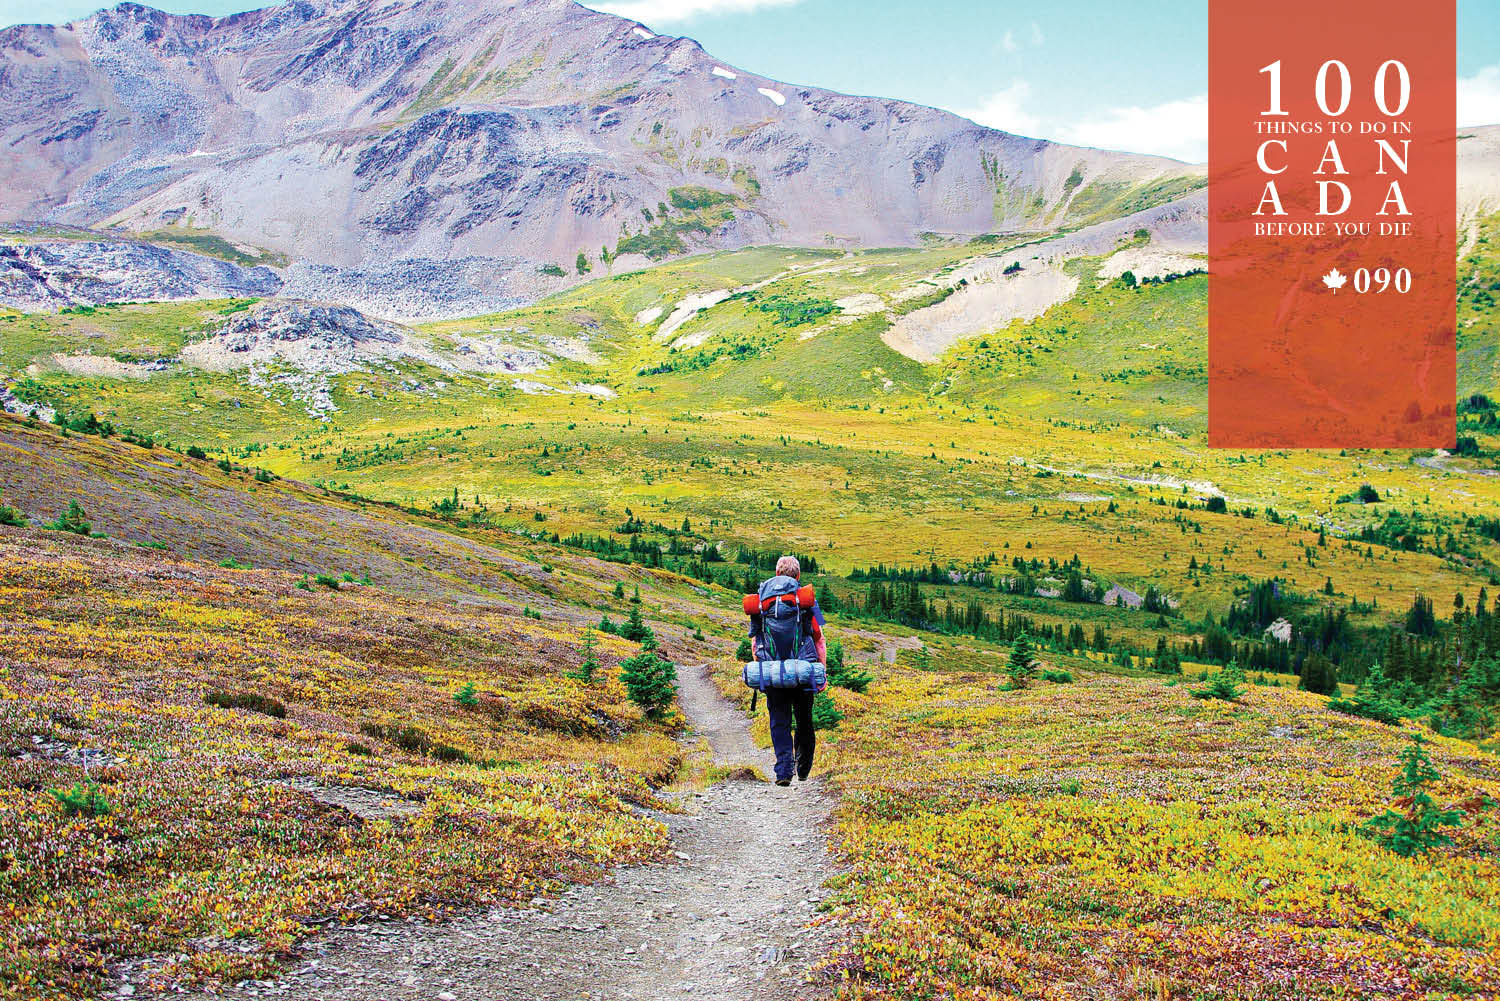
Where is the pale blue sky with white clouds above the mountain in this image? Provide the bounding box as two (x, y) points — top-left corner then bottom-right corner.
(0, 0), (1500, 162)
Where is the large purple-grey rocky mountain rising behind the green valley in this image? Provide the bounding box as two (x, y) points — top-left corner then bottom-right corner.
(0, 0), (1203, 317)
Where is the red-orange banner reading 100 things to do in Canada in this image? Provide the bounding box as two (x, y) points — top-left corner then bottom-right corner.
(1209, 0), (1458, 449)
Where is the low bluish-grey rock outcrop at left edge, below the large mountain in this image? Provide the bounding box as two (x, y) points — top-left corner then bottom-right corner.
(0, 240), (282, 311)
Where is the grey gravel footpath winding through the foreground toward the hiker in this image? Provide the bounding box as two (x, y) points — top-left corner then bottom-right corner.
(193, 668), (833, 1001)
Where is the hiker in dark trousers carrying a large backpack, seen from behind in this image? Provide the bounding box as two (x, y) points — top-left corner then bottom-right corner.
(750, 557), (828, 785)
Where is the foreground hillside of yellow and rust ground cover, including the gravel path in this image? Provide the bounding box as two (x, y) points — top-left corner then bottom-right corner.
(0, 419), (1500, 1001)
